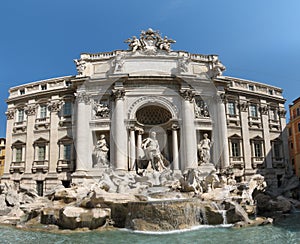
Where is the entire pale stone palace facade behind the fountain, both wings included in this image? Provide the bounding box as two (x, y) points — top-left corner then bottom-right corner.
(2, 29), (288, 195)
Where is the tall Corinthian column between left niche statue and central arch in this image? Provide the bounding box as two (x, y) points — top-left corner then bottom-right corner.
(112, 87), (128, 170)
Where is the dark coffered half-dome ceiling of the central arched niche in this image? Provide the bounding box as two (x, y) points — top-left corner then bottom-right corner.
(136, 105), (172, 125)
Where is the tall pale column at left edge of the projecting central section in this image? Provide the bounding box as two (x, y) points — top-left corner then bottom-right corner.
(75, 92), (89, 172)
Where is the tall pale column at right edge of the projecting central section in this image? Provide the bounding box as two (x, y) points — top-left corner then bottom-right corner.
(217, 93), (229, 168)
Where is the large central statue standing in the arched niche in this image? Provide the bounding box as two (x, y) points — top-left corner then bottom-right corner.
(142, 132), (168, 171)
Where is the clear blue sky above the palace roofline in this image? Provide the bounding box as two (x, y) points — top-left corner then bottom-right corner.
(0, 0), (300, 137)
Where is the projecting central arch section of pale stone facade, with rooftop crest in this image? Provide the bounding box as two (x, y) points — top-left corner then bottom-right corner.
(74, 29), (229, 181)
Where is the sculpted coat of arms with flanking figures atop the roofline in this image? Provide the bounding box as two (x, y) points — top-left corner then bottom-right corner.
(125, 28), (176, 54)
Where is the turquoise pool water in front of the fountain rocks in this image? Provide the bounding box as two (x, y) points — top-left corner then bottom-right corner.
(0, 213), (300, 244)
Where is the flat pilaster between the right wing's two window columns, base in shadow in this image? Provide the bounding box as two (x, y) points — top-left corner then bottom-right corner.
(260, 101), (273, 168)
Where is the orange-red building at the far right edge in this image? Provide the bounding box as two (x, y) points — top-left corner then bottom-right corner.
(288, 97), (300, 177)
